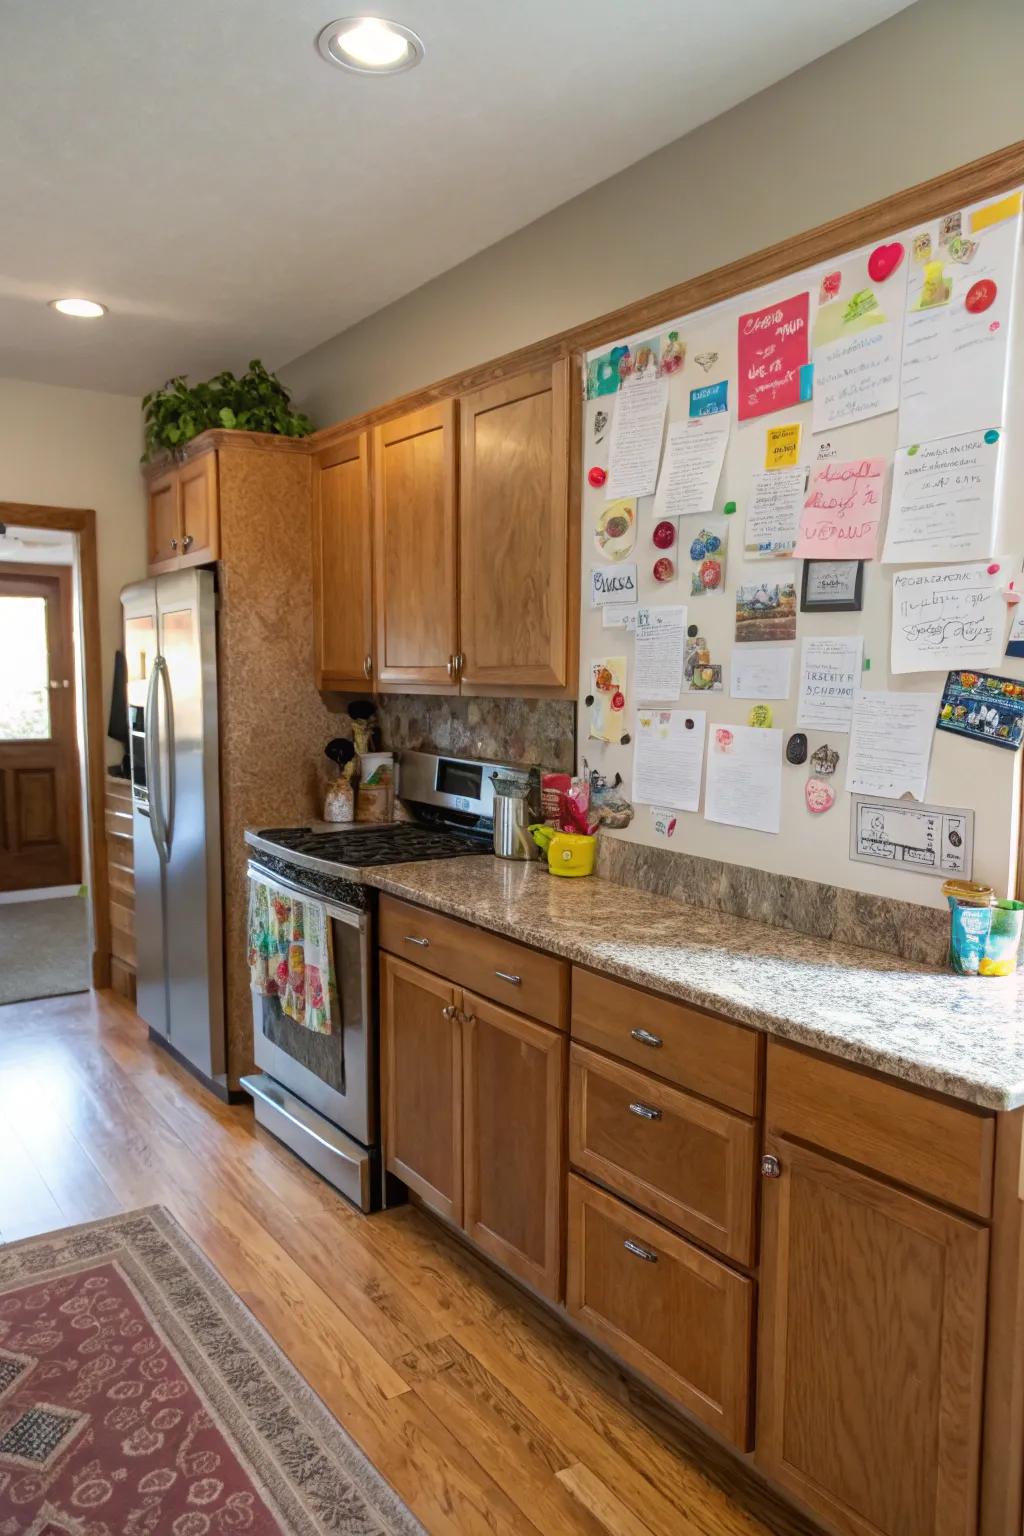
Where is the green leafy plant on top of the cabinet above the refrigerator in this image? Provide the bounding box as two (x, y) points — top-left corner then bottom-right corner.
(143, 358), (313, 459)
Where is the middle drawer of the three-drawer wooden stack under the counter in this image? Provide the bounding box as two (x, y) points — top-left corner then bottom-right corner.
(570, 1044), (757, 1264)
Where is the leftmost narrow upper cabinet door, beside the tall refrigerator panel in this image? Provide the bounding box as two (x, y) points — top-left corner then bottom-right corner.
(313, 432), (373, 688)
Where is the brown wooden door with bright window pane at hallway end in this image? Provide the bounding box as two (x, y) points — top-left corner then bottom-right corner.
(0, 564), (81, 891)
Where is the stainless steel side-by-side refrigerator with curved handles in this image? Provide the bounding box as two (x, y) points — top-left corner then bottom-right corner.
(121, 570), (227, 1095)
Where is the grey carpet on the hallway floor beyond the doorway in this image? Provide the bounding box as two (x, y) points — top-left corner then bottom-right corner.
(0, 895), (92, 1003)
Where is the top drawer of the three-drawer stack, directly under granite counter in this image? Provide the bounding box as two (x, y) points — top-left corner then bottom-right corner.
(571, 966), (761, 1115)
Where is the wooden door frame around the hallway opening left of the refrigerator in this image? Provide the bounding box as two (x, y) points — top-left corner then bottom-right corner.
(0, 501), (111, 991)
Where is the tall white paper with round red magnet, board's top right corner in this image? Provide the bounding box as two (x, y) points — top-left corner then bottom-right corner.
(898, 205), (1021, 447)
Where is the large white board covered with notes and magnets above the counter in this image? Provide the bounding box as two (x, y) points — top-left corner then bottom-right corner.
(579, 194), (1024, 906)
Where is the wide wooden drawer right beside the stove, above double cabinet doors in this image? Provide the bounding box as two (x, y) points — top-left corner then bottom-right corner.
(379, 895), (570, 1029)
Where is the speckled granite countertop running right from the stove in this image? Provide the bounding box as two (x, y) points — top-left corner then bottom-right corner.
(362, 854), (1024, 1109)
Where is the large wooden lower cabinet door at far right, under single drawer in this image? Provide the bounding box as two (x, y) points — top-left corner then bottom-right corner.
(757, 1137), (989, 1536)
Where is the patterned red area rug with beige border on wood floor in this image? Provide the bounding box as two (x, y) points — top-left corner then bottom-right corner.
(0, 1206), (422, 1536)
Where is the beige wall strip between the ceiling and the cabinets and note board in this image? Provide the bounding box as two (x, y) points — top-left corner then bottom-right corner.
(281, 0), (1024, 425)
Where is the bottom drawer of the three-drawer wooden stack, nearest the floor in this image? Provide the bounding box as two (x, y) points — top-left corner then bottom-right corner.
(567, 1174), (754, 1450)
